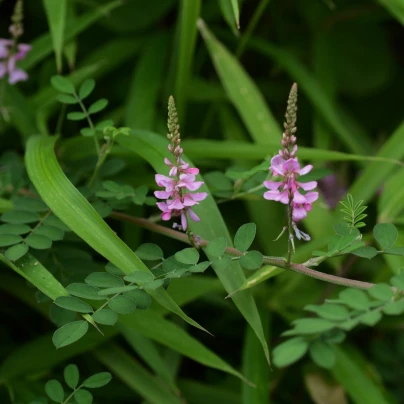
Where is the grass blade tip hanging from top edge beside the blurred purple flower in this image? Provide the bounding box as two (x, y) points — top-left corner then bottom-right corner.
(43, 0), (67, 73)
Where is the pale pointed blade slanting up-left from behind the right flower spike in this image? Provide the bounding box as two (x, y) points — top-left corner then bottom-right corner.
(198, 20), (282, 144)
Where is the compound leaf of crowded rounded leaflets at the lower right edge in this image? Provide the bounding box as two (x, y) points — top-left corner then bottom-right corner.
(273, 273), (404, 369)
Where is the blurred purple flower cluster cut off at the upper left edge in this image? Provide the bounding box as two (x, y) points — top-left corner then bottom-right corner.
(0, 39), (31, 84)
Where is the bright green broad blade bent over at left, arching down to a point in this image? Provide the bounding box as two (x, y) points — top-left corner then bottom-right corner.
(25, 136), (204, 330)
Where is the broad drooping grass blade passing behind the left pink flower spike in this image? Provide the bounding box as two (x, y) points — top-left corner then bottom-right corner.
(118, 131), (269, 362)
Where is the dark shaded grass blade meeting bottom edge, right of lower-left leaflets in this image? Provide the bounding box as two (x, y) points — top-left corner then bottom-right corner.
(94, 344), (182, 404)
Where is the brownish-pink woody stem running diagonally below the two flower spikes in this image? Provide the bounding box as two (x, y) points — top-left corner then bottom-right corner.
(111, 211), (374, 289)
